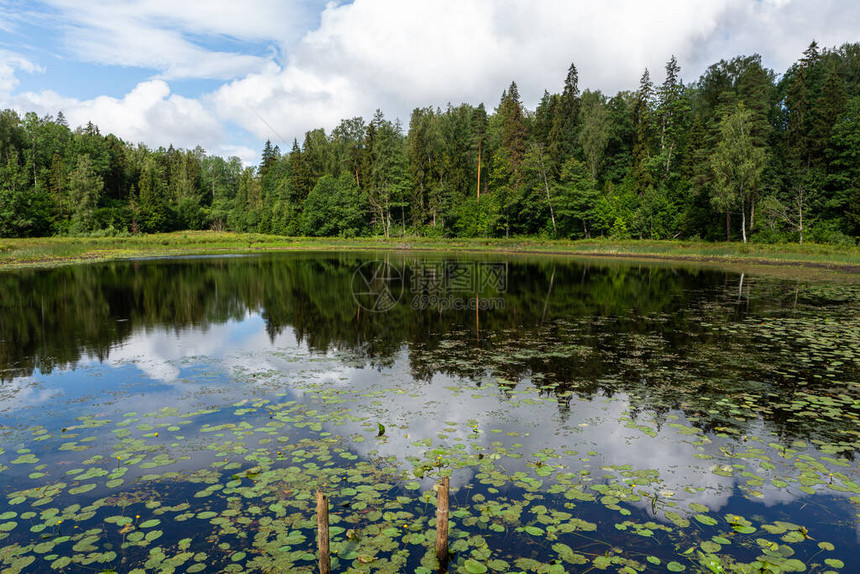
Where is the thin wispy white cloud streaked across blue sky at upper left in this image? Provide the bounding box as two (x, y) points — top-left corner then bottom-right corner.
(34, 0), (320, 80)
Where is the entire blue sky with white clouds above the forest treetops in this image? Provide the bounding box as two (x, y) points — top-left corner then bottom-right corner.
(0, 0), (860, 163)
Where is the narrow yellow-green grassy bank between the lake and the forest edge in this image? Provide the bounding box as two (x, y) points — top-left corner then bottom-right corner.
(0, 231), (860, 274)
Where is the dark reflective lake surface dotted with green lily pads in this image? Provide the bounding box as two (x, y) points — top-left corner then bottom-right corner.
(0, 253), (860, 573)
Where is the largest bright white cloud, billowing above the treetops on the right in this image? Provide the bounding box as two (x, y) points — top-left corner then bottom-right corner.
(213, 0), (860, 144)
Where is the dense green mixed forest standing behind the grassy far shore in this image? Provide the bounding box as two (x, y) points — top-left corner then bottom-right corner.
(0, 42), (860, 243)
